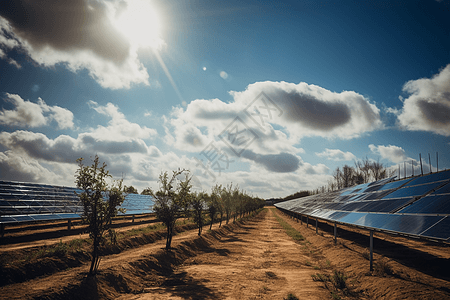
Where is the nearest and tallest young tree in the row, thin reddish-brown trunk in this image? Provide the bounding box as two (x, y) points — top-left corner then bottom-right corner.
(75, 155), (125, 275)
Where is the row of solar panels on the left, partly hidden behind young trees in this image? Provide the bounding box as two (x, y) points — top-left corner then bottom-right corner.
(0, 181), (153, 223)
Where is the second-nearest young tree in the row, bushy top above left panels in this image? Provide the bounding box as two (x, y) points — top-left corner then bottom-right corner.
(148, 170), (191, 250)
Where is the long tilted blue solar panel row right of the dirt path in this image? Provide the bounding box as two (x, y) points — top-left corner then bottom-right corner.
(275, 170), (450, 242)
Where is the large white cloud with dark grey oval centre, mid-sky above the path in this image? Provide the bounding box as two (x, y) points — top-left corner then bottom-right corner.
(166, 82), (382, 155)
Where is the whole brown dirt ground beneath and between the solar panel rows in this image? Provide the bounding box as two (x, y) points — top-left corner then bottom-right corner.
(0, 207), (450, 299)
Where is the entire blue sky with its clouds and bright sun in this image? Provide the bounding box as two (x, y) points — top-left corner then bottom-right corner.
(0, 0), (450, 198)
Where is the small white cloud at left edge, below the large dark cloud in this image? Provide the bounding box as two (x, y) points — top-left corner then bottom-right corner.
(0, 94), (73, 129)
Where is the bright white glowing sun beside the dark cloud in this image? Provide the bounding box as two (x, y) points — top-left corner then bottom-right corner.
(114, 0), (164, 49)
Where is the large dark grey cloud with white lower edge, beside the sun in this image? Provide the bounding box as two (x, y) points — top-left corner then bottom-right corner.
(0, 0), (163, 89)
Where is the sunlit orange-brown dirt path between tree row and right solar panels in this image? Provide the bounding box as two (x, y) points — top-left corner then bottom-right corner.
(120, 207), (330, 300)
